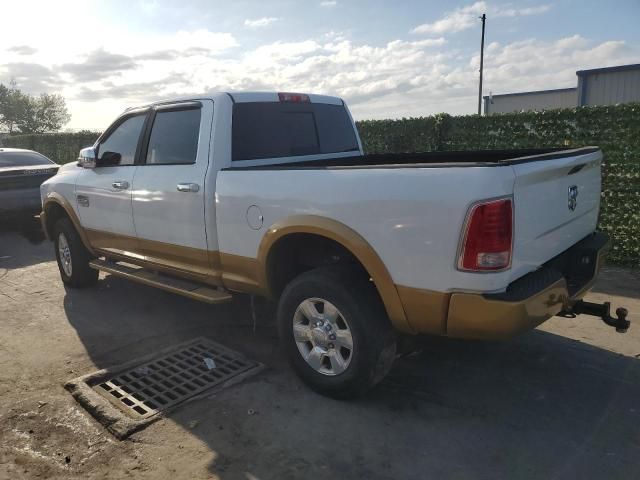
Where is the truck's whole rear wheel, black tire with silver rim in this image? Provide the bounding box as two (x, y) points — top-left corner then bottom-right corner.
(277, 266), (396, 399)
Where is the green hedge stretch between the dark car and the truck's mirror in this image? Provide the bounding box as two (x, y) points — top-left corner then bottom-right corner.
(1, 131), (100, 164)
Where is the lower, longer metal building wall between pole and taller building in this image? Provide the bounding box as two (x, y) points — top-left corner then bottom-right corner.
(484, 88), (578, 114)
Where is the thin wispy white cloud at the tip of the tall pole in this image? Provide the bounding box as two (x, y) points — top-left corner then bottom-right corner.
(411, 1), (551, 35)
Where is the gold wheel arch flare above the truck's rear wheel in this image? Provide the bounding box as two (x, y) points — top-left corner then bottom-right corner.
(258, 215), (412, 332)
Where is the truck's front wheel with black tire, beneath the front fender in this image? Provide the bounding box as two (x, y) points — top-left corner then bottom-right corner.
(53, 218), (99, 288)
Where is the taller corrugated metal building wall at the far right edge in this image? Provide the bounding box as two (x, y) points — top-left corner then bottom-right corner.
(578, 65), (640, 105)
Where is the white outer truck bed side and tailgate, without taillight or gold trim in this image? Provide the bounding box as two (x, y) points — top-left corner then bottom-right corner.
(216, 147), (602, 293)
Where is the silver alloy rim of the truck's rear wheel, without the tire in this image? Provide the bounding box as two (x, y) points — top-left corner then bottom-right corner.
(293, 298), (353, 376)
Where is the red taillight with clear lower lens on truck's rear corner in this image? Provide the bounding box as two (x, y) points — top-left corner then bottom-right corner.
(458, 198), (513, 271)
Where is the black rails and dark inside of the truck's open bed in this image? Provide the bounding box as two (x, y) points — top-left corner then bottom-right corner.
(225, 147), (598, 170)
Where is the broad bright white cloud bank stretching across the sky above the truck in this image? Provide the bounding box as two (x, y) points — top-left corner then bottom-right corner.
(0, 0), (640, 128)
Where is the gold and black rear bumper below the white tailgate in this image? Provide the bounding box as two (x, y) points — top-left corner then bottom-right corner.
(446, 233), (609, 340)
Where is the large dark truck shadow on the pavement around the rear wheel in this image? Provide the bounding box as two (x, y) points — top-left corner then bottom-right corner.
(64, 277), (640, 479)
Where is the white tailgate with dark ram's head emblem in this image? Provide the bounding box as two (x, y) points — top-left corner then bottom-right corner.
(512, 150), (602, 277)
